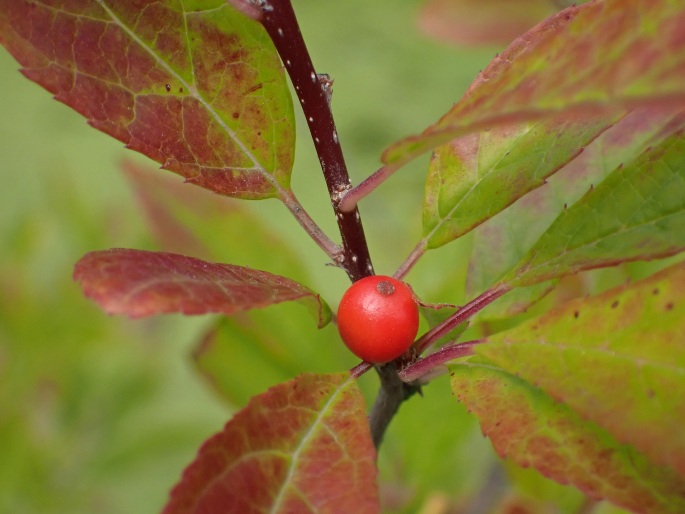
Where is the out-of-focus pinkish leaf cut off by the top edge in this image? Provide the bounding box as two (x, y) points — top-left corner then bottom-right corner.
(419, 0), (555, 45)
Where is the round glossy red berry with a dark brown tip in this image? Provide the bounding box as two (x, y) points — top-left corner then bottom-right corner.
(338, 275), (419, 364)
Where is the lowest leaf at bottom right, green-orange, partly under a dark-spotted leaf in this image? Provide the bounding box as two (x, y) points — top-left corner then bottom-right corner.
(451, 360), (685, 514)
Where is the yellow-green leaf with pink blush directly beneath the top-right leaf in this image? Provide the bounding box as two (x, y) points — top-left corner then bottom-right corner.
(423, 116), (614, 248)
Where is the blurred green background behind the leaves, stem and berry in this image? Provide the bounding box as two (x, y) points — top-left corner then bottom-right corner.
(0, 0), (600, 514)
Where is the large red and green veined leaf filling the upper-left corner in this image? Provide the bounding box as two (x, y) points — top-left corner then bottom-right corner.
(0, 0), (295, 198)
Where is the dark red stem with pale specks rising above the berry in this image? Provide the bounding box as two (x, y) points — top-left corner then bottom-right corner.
(259, 0), (373, 281)
